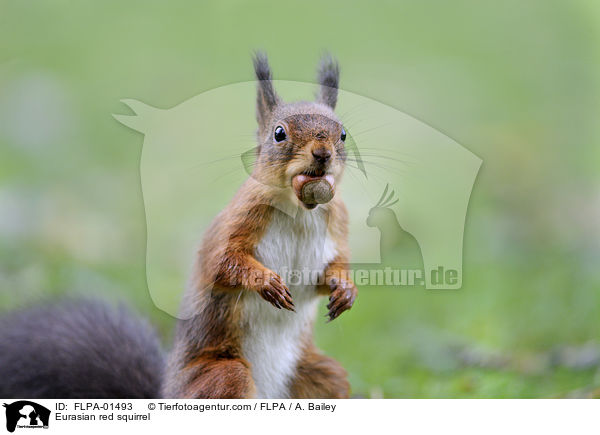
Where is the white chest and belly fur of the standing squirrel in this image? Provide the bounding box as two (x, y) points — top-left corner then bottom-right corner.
(242, 207), (335, 399)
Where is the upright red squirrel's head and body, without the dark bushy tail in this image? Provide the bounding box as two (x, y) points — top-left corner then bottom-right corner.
(163, 54), (357, 398)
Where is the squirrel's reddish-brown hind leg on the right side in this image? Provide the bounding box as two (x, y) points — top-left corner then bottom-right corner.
(290, 346), (350, 399)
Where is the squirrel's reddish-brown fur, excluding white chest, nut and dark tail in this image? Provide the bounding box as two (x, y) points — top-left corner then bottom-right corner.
(163, 53), (356, 398)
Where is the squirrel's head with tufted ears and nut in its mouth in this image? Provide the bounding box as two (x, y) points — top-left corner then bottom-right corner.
(252, 53), (346, 209)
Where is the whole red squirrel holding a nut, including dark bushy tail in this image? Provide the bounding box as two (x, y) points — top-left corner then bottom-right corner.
(0, 54), (357, 398)
